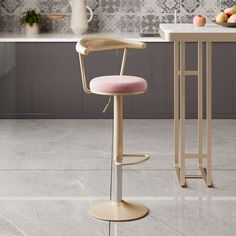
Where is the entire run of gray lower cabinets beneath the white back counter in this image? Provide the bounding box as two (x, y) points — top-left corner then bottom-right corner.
(0, 43), (236, 118)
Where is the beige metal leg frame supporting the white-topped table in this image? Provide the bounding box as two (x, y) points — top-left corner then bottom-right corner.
(174, 42), (212, 187)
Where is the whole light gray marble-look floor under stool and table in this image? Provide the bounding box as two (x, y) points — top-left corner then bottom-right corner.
(0, 120), (236, 236)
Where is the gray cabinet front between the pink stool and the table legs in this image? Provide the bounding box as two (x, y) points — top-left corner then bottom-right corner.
(127, 43), (173, 118)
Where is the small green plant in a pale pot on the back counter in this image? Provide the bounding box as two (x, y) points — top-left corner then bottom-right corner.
(21, 9), (42, 35)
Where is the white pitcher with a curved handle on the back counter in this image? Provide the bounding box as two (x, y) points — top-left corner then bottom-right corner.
(69, 0), (93, 34)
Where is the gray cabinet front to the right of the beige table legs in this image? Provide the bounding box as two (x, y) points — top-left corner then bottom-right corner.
(212, 43), (236, 118)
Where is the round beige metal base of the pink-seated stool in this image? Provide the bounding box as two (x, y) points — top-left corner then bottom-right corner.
(89, 201), (149, 221)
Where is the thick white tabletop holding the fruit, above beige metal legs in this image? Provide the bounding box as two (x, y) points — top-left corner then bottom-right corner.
(160, 24), (236, 42)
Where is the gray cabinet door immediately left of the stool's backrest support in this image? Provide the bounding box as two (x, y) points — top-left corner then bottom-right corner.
(32, 43), (83, 118)
